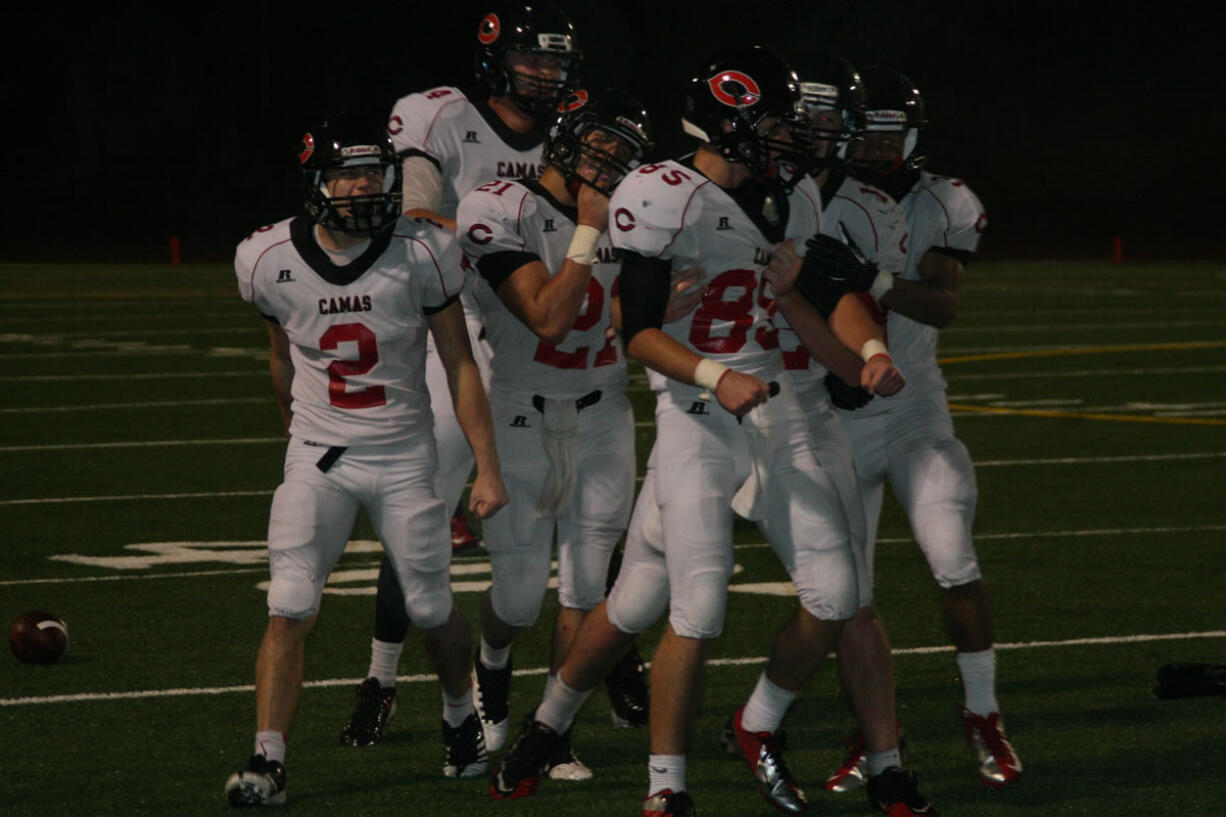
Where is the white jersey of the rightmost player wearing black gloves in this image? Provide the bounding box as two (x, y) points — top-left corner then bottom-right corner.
(861, 171), (988, 402)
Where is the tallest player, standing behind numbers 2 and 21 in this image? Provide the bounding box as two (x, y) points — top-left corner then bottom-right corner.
(341, 0), (645, 751)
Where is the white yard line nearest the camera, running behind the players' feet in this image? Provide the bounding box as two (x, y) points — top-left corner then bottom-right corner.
(0, 629), (1226, 707)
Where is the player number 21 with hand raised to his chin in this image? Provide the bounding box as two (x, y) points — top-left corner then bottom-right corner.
(457, 90), (651, 780)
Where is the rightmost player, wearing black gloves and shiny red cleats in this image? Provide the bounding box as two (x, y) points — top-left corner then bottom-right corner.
(842, 67), (1021, 786)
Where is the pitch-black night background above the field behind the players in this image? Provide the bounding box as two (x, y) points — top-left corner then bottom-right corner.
(0, 0), (1226, 263)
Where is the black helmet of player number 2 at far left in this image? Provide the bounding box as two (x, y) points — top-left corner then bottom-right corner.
(298, 114), (401, 237)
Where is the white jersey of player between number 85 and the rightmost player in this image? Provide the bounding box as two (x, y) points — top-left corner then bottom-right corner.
(776, 170), (907, 391)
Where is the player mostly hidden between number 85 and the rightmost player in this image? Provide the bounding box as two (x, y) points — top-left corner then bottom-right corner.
(771, 54), (927, 799)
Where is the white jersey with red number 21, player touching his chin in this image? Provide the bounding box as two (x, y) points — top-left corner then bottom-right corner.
(456, 180), (626, 399)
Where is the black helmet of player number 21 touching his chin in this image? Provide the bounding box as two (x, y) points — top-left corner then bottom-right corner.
(544, 88), (652, 195)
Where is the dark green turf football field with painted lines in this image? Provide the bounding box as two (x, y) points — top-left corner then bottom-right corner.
(0, 261), (1226, 817)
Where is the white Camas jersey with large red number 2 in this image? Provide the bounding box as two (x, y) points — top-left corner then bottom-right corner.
(234, 216), (463, 445)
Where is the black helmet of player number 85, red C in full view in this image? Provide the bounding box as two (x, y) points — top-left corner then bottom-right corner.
(682, 45), (813, 183)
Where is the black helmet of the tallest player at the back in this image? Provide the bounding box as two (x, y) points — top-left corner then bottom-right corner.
(476, 0), (584, 117)
